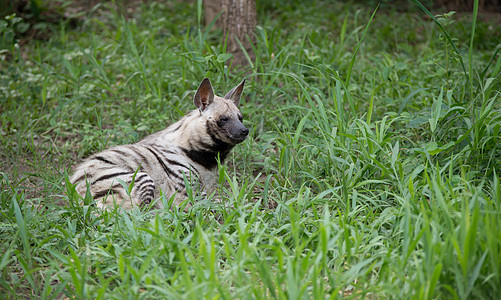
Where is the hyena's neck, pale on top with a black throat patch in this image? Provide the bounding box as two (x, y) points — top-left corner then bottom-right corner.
(145, 110), (233, 170)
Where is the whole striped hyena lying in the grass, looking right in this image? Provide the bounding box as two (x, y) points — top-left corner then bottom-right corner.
(70, 78), (249, 209)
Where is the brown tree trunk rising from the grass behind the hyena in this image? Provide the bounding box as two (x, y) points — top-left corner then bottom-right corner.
(204, 0), (257, 66)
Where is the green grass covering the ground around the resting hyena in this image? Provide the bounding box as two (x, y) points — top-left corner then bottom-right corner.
(0, 1), (501, 299)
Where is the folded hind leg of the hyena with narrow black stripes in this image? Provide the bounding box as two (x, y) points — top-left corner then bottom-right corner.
(77, 172), (156, 209)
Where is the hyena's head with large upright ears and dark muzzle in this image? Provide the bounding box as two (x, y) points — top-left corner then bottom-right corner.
(193, 78), (249, 145)
